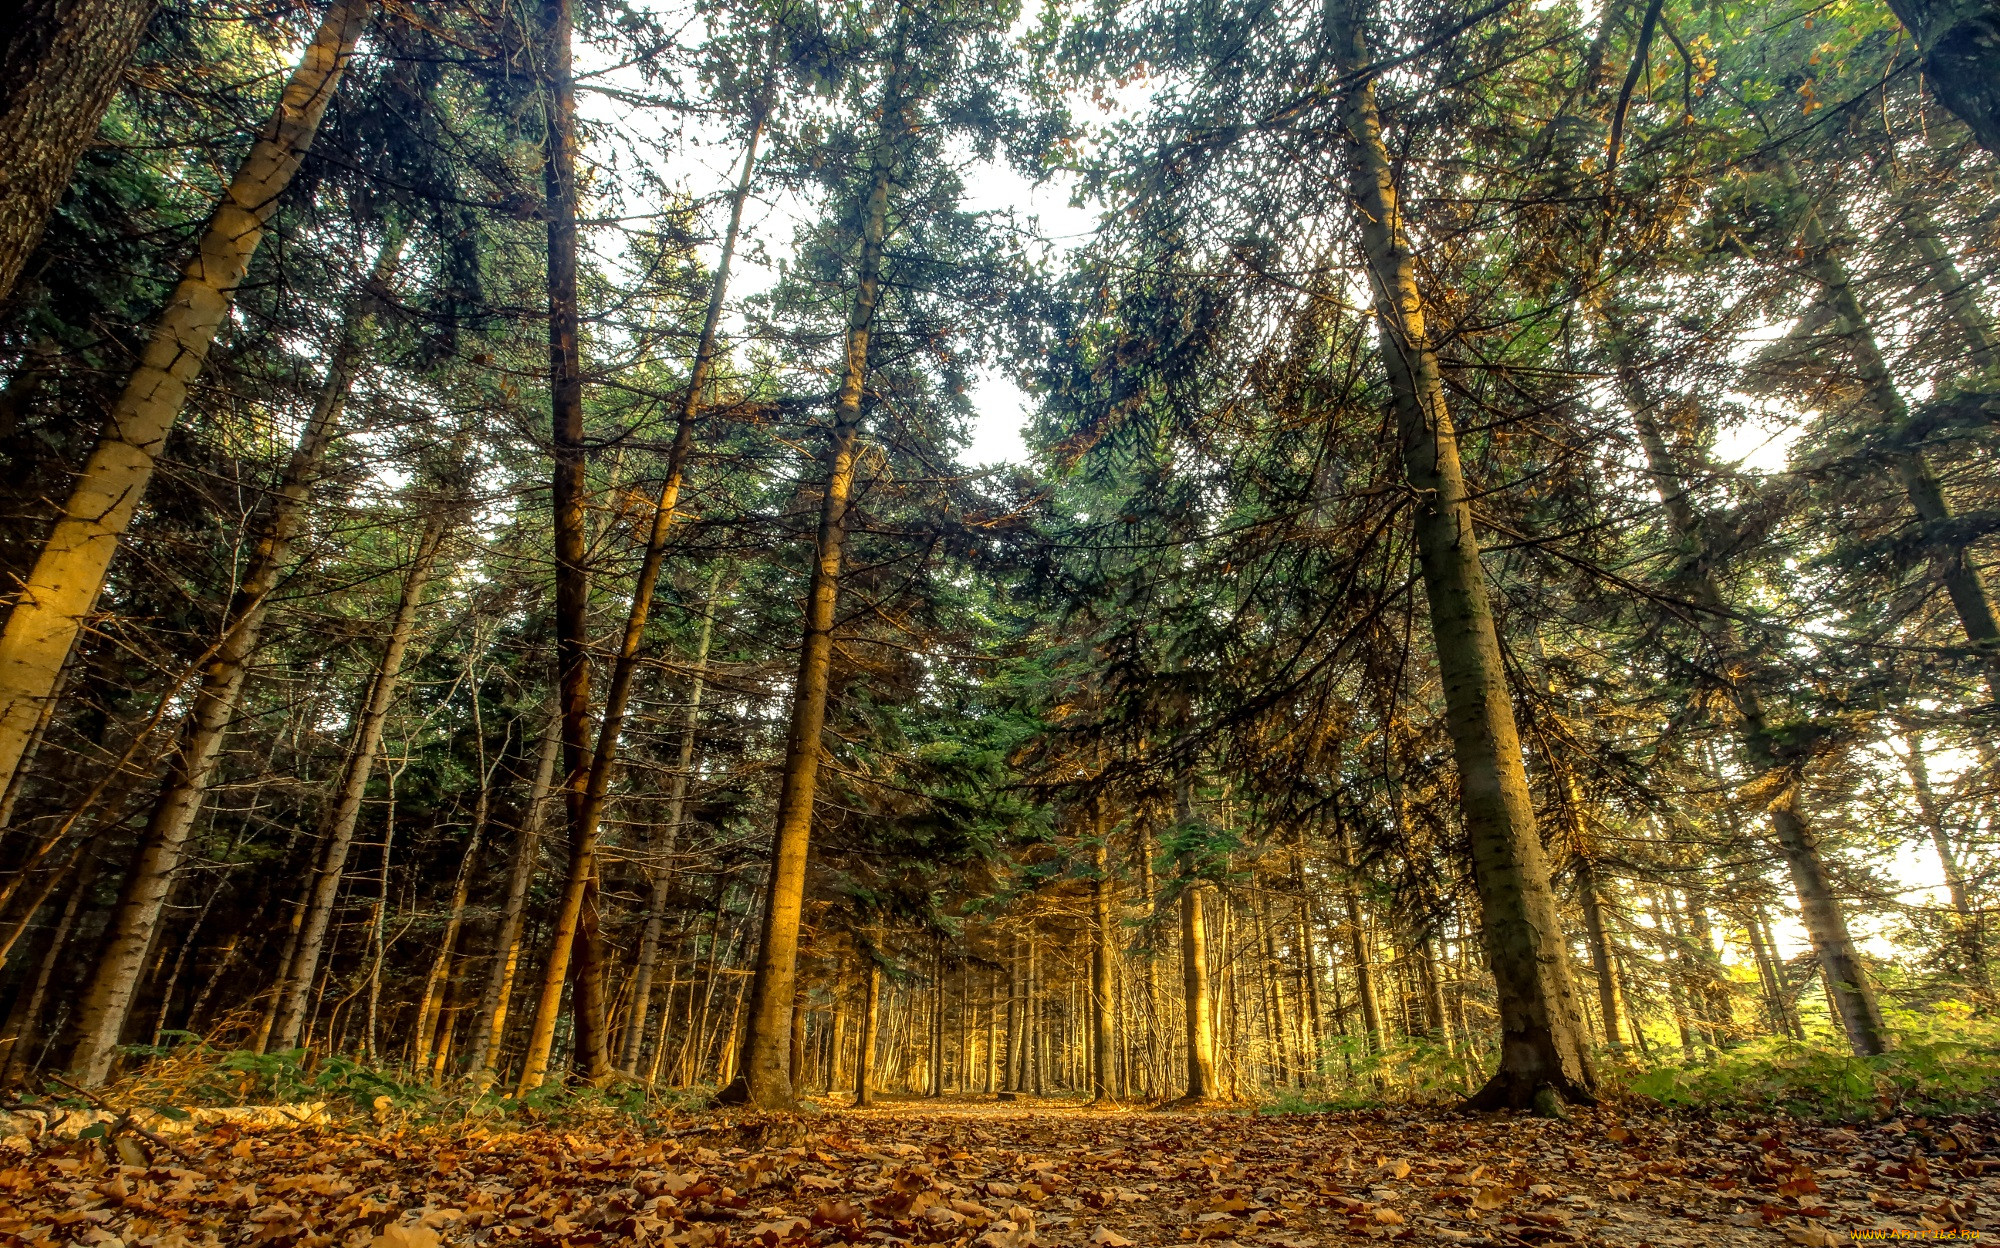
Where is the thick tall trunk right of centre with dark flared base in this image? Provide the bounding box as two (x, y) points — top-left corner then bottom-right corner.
(1332, 0), (1596, 1112)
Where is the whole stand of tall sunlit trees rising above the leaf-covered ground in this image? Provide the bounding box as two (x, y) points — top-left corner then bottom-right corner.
(0, 0), (2000, 1152)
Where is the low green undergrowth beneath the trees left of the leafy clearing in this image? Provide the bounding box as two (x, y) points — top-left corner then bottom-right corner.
(35, 1036), (714, 1128)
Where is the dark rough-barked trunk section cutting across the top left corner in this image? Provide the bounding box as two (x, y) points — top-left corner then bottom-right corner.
(0, 0), (156, 300)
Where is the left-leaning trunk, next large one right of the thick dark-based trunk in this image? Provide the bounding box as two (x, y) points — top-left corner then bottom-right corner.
(1606, 332), (1888, 1054)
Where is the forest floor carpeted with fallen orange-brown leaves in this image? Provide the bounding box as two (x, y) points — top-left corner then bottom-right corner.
(0, 1098), (2000, 1248)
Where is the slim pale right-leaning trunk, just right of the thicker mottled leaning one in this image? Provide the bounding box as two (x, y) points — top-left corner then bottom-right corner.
(276, 502), (448, 1048)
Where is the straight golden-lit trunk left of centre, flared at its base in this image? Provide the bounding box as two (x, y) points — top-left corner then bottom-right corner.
(722, 80), (910, 1108)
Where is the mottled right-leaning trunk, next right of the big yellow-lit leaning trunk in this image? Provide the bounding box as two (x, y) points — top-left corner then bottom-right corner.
(70, 238), (402, 1088)
